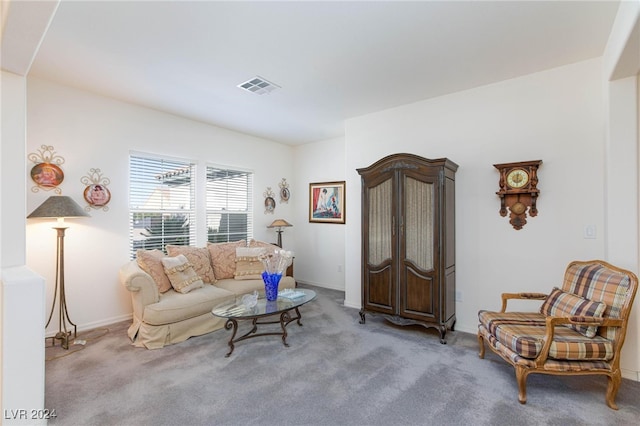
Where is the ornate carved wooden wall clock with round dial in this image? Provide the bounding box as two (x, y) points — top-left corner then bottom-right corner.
(493, 160), (542, 230)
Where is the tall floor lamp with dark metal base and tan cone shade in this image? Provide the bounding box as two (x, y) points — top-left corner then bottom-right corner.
(27, 195), (89, 349)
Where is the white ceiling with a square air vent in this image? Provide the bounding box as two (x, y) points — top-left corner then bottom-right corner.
(2, 0), (619, 145)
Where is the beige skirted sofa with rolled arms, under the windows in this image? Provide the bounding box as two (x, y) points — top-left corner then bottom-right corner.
(119, 241), (296, 349)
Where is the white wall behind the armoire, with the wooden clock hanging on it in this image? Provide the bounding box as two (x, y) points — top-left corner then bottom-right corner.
(346, 60), (605, 333)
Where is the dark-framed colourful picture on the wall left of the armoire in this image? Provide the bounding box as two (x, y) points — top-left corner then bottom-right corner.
(309, 181), (346, 224)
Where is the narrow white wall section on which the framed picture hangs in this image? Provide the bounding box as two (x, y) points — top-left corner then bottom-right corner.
(294, 138), (348, 290)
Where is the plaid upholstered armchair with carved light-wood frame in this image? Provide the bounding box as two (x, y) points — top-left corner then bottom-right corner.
(478, 260), (638, 410)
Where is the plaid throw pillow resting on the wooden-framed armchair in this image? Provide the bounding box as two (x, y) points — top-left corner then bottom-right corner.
(540, 287), (607, 338)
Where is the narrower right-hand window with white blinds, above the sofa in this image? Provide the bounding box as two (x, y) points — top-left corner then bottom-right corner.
(206, 166), (253, 243)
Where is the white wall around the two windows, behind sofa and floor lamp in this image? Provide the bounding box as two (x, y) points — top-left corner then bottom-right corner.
(25, 78), (295, 334)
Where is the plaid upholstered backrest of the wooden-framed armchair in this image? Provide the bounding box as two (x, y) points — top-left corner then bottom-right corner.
(562, 260), (638, 343)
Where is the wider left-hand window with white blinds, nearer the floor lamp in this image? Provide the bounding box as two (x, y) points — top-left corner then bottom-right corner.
(129, 155), (196, 259)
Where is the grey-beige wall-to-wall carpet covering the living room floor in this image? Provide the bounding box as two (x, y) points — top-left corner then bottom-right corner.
(45, 287), (640, 426)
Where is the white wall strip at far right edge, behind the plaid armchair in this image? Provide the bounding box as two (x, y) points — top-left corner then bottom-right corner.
(603, 1), (640, 380)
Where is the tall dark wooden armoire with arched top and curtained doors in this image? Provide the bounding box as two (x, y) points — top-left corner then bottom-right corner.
(357, 154), (458, 343)
